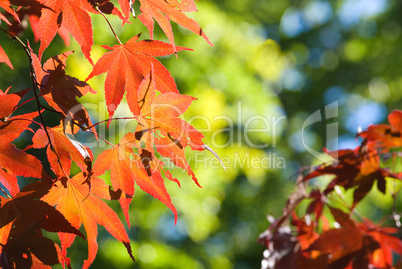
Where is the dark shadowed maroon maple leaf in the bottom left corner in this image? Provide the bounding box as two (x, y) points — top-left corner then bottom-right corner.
(0, 181), (84, 268)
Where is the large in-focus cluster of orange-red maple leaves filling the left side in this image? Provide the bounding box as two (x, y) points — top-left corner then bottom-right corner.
(0, 0), (209, 268)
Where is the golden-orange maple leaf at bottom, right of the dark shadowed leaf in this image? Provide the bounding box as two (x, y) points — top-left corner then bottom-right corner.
(42, 173), (134, 268)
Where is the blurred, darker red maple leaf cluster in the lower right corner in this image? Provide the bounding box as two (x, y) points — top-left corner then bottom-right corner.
(258, 110), (402, 269)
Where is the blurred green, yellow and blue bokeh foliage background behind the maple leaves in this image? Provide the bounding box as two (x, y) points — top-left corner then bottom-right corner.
(0, 0), (402, 269)
